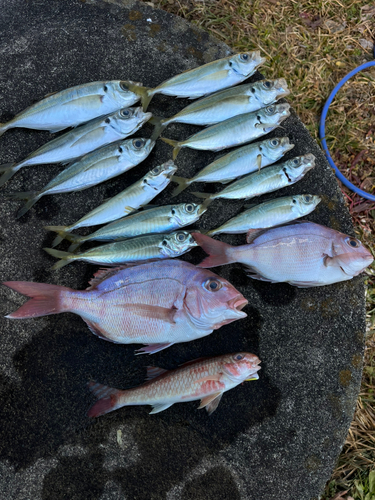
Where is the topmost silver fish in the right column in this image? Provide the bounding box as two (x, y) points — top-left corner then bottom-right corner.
(129, 50), (266, 111)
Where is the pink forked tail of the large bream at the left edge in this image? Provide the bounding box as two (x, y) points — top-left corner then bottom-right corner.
(3, 281), (74, 319)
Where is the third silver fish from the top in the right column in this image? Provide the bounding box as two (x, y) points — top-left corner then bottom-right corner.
(161, 103), (290, 160)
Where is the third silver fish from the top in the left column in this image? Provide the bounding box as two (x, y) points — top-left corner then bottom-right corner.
(7, 138), (155, 219)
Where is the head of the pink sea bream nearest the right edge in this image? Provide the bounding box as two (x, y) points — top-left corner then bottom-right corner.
(331, 235), (374, 276)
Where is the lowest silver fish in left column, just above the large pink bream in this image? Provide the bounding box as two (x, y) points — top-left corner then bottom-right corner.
(44, 231), (197, 270)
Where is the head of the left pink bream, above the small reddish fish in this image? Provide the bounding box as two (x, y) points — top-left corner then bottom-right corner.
(184, 268), (248, 330)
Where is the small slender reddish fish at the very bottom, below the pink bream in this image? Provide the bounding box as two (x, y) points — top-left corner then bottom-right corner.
(88, 352), (260, 417)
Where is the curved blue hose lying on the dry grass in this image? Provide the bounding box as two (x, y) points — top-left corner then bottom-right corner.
(319, 45), (375, 201)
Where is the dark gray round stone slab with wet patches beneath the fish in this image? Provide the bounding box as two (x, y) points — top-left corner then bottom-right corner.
(0, 0), (365, 500)
